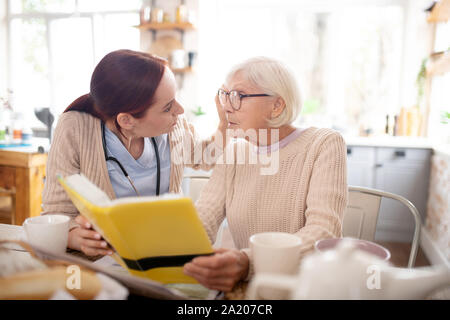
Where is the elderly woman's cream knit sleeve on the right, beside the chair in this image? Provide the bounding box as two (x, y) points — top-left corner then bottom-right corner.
(296, 132), (348, 257)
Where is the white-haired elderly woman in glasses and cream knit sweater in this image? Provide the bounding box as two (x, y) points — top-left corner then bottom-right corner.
(184, 57), (347, 291)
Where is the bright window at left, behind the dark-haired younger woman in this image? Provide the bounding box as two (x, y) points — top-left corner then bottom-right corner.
(7, 0), (141, 120)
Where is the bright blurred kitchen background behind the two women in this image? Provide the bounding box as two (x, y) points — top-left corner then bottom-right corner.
(0, 0), (450, 262)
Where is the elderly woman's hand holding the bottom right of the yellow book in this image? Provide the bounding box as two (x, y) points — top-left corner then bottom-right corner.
(183, 248), (249, 292)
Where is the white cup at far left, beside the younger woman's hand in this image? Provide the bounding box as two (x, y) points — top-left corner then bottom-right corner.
(23, 214), (70, 254)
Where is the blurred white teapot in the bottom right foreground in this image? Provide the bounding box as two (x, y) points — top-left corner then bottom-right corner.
(247, 239), (450, 300)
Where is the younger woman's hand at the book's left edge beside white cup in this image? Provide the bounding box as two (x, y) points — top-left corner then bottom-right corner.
(67, 215), (113, 256)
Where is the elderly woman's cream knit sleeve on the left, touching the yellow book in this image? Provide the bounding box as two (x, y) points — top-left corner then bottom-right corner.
(195, 164), (226, 243)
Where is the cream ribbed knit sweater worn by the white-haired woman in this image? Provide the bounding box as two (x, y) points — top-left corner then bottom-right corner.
(196, 128), (347, 276)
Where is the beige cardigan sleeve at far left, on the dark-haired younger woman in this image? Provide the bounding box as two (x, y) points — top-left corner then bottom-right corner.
(41, 112), (80, 229)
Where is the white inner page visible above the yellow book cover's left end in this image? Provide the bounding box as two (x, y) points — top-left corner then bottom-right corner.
(65, 174), (111, 207)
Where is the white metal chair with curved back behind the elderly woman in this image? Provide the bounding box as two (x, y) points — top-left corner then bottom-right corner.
(343, 186), (422, 268)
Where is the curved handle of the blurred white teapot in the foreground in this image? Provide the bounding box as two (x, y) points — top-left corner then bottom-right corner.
(247, 273), (298, 300)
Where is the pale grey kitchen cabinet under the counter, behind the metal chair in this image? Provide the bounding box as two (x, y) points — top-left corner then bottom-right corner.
(347, 145), (431, 242)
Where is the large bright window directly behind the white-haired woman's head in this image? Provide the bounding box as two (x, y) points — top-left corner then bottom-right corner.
(198, 0), (405, 134)
